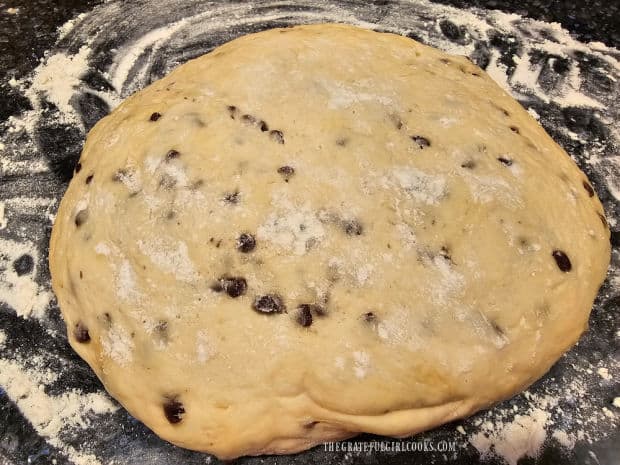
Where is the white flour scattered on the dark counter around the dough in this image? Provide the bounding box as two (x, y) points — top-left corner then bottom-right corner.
(0, 0), (620, 465)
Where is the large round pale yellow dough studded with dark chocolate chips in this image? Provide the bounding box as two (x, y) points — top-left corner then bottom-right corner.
(50, 25), (610, 458)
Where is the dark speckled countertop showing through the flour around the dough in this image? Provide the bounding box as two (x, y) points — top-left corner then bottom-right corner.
(0, 0), (620, 465)
